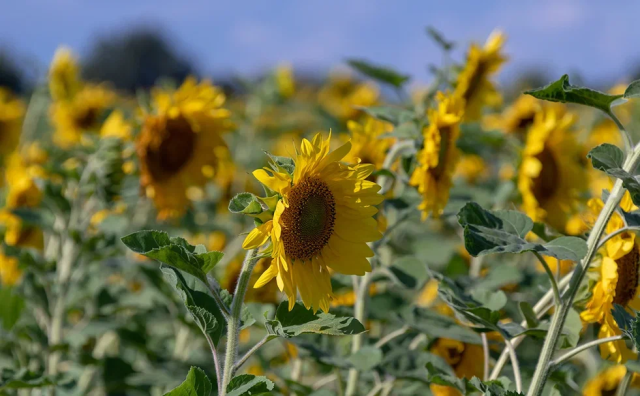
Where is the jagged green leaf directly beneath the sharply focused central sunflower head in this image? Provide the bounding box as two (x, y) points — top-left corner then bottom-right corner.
(265, 301), (365, 338)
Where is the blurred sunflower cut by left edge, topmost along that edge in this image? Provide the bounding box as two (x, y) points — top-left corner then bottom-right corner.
(0, 87), (25, 159)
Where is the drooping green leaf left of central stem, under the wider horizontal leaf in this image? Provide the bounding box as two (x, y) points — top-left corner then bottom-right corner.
(160, 266), (226, 346)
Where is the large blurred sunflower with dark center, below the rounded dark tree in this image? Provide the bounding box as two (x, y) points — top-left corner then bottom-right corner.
(136, 78), (231, 219)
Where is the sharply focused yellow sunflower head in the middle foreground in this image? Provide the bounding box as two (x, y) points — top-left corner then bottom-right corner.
(243, 134), (383, 312)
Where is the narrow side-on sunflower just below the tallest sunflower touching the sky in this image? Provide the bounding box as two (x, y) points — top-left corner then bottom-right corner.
(409, 92), (463, 220)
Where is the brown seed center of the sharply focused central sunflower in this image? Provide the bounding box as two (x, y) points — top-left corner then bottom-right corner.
(281, 178), (336, 261)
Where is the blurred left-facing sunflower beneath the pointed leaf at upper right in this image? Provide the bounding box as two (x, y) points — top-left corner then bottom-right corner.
(518, 108), (587, 231)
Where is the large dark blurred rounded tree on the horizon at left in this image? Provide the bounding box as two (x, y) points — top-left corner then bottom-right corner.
(83, 28), (194, 92)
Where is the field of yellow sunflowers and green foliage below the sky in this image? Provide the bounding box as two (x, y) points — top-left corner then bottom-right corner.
(0, 30), (640, 396)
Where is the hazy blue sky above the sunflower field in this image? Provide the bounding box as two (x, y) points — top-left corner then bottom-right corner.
(0, 0), (640, 87)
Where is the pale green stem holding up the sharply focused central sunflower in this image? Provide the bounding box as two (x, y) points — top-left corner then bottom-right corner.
(220, 249), (258, 396)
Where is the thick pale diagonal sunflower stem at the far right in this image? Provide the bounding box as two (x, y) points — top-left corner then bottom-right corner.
(527, 145), (640, 396)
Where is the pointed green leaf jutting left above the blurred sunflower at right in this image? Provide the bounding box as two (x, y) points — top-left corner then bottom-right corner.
(524, 74), (622, 113)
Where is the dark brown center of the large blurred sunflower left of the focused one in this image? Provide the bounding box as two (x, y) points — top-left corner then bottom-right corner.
(147, 117), (196, 180)
